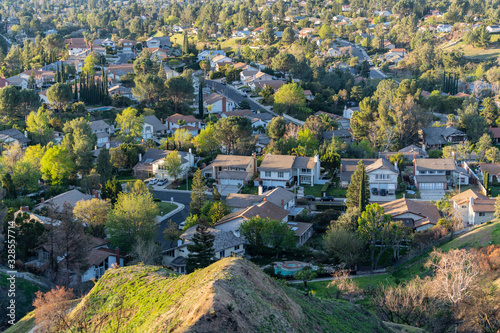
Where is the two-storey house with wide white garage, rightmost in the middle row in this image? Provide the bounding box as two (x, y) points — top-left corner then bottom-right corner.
(413, 158), (457, 190)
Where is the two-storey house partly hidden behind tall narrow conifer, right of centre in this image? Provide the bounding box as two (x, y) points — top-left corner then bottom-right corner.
(340, 158), (399, 194)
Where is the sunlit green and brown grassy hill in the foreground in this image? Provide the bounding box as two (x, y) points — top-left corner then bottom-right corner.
(60, 258), (389, 333)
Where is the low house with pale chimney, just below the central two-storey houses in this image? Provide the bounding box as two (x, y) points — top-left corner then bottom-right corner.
(225, 186), (297, 211)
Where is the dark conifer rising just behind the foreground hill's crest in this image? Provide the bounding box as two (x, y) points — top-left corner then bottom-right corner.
(186, 224), (215, 273)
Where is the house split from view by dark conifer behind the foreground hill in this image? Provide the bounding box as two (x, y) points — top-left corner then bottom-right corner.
(162, 226), (245, 274)
